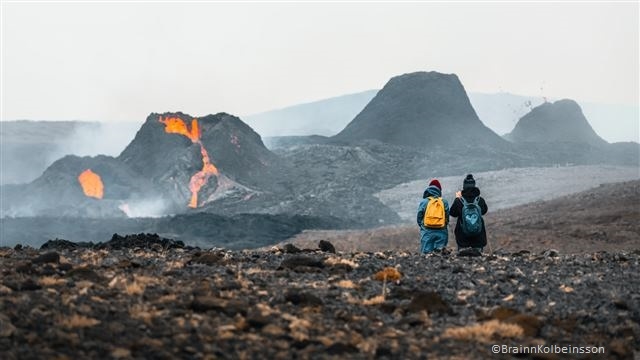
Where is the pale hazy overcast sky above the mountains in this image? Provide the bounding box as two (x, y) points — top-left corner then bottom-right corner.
(1, 2), (639, 121)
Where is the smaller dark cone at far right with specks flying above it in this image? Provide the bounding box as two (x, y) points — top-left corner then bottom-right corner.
(505, 99), (607, 146)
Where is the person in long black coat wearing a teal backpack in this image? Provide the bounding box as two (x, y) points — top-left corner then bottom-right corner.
(449, 174), (489, 255)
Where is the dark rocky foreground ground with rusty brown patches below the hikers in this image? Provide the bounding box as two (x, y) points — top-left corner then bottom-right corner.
(0, 234), (640, 359)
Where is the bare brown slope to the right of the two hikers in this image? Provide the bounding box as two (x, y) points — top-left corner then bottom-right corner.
(487, 180), (640, 253)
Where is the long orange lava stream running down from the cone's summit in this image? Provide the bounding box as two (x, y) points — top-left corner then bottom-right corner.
(158, 116), (218, 208)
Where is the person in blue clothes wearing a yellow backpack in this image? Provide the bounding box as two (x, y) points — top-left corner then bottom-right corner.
(417, 179), (449, 254)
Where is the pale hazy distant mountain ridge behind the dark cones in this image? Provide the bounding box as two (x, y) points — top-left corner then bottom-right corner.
(242, 90), (640, 142)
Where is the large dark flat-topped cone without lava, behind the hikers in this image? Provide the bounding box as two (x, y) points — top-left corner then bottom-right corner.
(333, 71), (507, 148)
